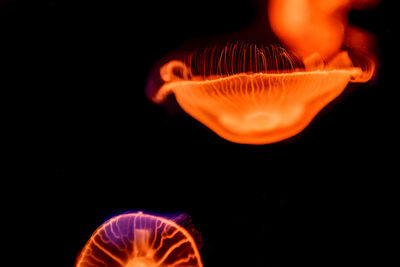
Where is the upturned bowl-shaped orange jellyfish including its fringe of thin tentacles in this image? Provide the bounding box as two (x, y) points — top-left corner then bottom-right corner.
(151, 44), (370, 144)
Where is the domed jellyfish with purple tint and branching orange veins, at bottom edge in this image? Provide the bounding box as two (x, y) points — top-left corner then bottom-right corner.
(76, 212), (203, 267)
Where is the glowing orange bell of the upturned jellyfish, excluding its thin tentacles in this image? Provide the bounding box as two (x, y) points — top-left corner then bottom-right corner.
(154, 53), (362, 144)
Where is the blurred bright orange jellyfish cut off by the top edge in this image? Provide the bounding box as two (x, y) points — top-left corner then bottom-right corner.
(268, 0), (379, 59)
